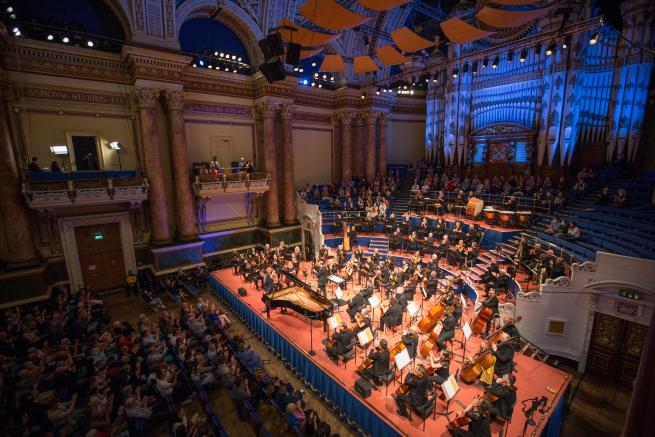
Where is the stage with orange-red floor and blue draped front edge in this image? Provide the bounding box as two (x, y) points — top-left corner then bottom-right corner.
(211, 265), (571, 437)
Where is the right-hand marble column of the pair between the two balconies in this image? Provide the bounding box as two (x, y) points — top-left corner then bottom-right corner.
(164, 91), (198, 241)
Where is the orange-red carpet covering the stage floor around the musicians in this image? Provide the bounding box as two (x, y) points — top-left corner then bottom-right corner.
(212, 265), (570, 437)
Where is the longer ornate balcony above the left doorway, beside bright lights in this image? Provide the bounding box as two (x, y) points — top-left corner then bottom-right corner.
(22, 171), (148, 209)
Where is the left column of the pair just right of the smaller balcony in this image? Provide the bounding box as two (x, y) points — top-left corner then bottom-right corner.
(255, 103), (280, 227)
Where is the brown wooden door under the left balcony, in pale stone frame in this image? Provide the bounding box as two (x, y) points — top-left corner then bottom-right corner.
(75, 223), (126, 290)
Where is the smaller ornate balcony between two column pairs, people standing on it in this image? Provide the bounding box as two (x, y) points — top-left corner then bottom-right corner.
(193, 172), (270, 197)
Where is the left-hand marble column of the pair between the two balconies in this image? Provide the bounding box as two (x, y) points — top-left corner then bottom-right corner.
(134, 88), (171, 244)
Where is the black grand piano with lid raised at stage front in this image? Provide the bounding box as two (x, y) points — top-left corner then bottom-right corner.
(262, 270), (333, 321)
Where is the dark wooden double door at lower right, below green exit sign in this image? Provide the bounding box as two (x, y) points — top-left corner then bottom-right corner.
(587, 313), (648, 383)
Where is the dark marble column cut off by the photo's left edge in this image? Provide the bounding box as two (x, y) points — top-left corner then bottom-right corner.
(0, 84), (37, 268)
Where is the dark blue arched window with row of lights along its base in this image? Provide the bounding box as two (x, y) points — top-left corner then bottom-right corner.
(180, 18), (251, 74)
